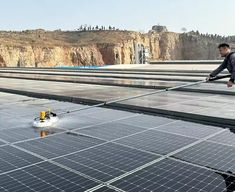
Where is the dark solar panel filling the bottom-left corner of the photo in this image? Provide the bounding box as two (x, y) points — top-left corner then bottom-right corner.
(0, 162), (97, 192)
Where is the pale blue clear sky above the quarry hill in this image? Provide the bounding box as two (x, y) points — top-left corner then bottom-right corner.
(0, 0), (235, 36)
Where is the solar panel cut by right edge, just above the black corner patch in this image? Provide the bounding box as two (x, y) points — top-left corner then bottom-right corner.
(175, 142), (235, 173)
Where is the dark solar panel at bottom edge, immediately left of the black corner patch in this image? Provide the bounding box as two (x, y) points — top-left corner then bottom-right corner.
(111, 159), (232, 192)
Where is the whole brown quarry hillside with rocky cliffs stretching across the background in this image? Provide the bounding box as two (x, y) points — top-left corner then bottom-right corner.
(0, 26), (231, 67)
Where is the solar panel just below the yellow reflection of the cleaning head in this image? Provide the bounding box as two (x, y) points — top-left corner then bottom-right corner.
(16, 133), (104, 158)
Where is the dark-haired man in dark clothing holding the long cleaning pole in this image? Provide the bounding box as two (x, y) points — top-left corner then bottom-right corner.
(207, 43), (235, 87)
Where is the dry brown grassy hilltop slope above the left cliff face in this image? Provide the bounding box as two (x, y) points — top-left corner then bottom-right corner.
(0, 29), (138, 46)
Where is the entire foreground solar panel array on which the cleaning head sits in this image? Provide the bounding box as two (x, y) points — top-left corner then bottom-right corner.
(0, 93), (235, 192)
